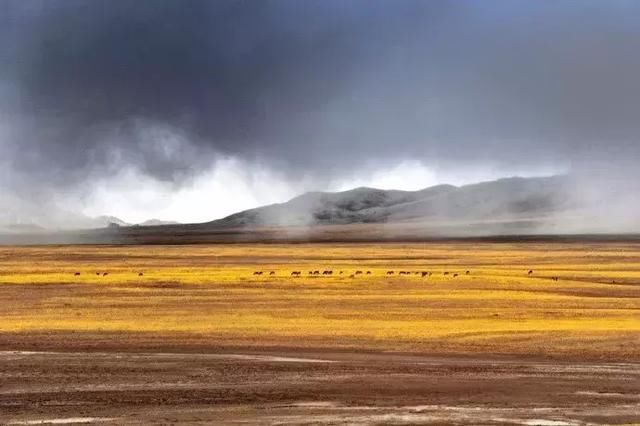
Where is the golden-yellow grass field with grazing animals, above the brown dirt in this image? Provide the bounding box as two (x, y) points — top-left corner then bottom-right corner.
(0, 242), (640, 361)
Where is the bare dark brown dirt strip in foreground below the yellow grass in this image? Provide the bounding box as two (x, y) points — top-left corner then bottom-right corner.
(0, 351), (640, 425)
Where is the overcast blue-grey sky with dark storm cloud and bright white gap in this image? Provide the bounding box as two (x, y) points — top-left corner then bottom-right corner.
(0, 0), (640, 222)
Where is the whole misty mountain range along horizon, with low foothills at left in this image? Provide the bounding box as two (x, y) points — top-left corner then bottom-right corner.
(0, 176), (640, 243)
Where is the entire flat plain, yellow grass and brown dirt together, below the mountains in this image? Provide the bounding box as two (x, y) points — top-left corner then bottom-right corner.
(0, 242), (640, 426)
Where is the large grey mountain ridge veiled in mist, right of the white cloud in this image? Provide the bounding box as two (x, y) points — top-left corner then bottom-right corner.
(206, 176), (580, 227)
